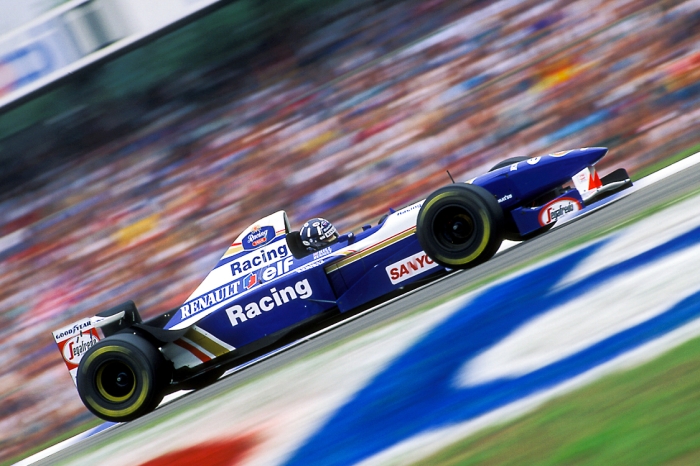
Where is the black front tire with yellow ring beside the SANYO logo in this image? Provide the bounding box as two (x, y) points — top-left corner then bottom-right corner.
(416, 184), (503, 269)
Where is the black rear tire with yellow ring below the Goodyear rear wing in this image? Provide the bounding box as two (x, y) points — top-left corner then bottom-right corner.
(78, 333), (170, 422)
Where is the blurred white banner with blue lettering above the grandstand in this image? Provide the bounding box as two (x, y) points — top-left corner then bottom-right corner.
(0, 0), (220, 107)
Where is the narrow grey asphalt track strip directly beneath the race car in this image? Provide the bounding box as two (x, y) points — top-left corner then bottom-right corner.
(34, 159), (700, 465)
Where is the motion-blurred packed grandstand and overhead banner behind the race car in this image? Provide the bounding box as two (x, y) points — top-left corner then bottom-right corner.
(0, 0), (700, 461)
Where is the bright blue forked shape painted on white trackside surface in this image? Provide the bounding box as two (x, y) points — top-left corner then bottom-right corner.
(287, 228), (700, 465)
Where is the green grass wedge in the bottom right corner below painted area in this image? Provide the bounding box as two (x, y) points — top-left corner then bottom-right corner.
(417, 338), (700, 466)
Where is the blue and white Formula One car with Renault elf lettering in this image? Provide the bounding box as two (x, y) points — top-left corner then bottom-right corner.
(54, 147), (631, 421)
